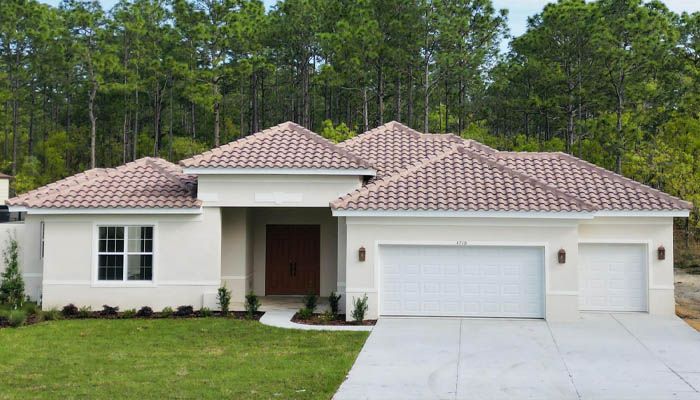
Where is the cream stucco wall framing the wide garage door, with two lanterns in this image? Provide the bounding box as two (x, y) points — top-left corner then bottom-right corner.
(345, 217), (578, 320)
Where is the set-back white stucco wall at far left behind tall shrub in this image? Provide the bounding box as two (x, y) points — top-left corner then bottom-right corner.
(0, 219), (42, 300)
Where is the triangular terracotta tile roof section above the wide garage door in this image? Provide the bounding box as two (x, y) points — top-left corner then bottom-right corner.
(331, 144), (591, 212)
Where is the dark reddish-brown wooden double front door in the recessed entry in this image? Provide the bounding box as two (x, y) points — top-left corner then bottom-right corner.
(265, 225), (321, 295)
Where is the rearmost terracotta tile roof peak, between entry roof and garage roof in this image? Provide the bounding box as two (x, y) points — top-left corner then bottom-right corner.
(338, 121), (495, 176)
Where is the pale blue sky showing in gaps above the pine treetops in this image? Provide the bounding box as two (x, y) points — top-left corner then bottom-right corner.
(39, 0), (700, 41)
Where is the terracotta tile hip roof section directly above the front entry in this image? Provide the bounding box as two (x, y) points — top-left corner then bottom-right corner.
(180, 122), (372, 169)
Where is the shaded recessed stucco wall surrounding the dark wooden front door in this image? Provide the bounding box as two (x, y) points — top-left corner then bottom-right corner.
(252, 208), (338, 296)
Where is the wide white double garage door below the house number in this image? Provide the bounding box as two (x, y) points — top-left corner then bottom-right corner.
(380, 245), (544, 318)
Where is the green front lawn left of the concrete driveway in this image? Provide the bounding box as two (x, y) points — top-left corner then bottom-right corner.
(0, 318), (368, 399)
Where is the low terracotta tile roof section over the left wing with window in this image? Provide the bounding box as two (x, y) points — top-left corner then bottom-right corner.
(5, 157), (201, 208)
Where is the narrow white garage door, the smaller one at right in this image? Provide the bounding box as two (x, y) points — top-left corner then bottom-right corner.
(579, 244), (647, 311)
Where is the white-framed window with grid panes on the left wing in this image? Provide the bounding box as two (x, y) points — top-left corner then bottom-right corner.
(97, 225), (153, 281)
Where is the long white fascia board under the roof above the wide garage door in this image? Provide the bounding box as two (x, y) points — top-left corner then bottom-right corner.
(333, 210), (593, 219)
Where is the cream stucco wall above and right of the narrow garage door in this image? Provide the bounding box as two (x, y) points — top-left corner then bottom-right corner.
(578, 218), (675, 315)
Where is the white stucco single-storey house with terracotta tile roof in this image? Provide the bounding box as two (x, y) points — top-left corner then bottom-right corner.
(2, 122), (692, 320)
